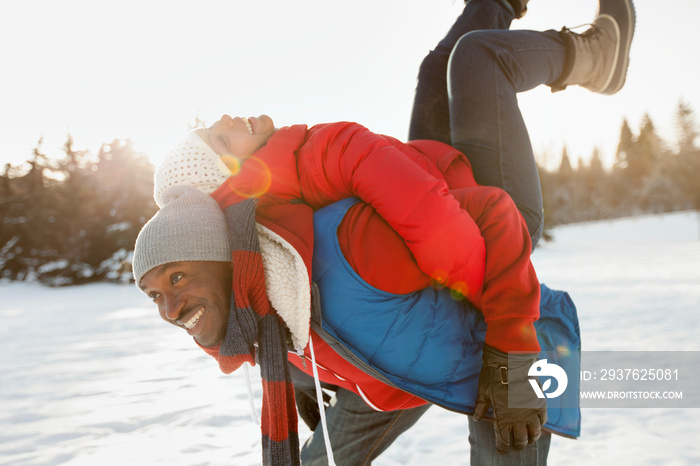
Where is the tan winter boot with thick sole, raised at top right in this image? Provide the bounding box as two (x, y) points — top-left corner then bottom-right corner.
(551, 0), (635, 95)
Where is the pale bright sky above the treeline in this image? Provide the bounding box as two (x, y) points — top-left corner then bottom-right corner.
(0, 0), (700, 170)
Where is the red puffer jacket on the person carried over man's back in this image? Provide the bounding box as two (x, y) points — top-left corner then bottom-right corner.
(212, 122), (539, 351)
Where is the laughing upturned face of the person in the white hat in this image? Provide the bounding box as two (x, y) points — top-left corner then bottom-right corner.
(197, 115), (276, 160)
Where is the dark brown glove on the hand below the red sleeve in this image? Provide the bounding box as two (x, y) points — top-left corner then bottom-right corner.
(474, 345), (547, 453)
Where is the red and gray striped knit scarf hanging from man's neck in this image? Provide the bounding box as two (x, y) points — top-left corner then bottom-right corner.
(198, 199), (300, 466)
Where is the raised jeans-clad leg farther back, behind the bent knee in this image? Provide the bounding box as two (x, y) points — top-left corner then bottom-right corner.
(408, 0), (514, 144)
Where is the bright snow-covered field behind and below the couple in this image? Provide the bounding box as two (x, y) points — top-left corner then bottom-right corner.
(0, 213), (700, 466)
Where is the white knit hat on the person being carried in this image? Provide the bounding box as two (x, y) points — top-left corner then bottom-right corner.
(153, 131), (231, 207)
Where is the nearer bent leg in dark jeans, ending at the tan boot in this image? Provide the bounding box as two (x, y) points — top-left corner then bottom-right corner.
(447, 31), (565, 249)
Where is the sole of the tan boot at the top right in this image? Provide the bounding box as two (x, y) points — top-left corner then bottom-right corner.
(598, 0), (637, 95)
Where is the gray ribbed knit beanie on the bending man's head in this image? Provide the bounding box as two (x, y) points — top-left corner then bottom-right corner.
(133, 185), (231, 286)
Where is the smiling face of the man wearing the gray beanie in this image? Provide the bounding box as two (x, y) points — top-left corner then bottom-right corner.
(139, 261), (231, 347)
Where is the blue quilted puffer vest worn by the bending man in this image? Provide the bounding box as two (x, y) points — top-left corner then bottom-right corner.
(312, 199), (581, 437)
